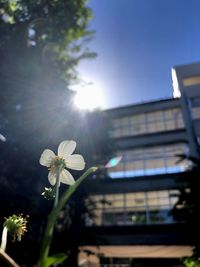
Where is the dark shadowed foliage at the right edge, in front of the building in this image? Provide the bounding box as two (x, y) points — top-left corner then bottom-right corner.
(172, 155), (200, 261)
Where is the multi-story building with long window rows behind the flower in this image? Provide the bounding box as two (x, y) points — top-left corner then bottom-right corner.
(79, 63), (200, 267)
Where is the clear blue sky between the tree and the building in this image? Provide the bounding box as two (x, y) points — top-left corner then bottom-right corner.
(79, 0), (200, 108)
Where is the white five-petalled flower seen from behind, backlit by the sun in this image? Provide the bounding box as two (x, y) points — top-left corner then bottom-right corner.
(40, 140), (85, 185)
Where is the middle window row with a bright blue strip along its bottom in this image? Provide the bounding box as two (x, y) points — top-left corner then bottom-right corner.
(109, 143), (188, 178)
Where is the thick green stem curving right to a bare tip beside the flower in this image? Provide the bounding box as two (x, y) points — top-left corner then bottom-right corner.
(37, 167), (97, 267)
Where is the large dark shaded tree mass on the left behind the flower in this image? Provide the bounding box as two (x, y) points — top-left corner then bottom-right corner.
(0, 0), (110, 267)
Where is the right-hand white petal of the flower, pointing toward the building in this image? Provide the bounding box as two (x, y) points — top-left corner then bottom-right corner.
(65, 154), (85, 171)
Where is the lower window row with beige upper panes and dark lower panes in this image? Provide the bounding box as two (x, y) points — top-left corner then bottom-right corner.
(86, 190), (178, 226)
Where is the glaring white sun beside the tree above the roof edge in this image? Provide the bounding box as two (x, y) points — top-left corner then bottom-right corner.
(74, 85), (104, 110)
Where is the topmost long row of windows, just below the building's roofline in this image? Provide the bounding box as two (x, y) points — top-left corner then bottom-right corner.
(111, 108), (184, 137)
